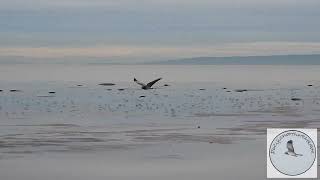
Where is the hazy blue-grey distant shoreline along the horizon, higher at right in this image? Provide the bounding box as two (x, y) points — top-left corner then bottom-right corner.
(0, 54), (320, 65)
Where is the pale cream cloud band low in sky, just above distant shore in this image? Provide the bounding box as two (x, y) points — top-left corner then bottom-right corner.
(0, 42), (320, 61)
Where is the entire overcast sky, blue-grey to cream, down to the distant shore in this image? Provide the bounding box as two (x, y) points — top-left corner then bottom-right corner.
(0, 0), (320, 61)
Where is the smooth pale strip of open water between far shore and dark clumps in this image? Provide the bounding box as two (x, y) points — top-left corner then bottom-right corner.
(0, 64), (320, 86)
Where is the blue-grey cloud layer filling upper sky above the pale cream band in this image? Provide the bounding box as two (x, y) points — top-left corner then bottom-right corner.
(0, 0), (320, 58)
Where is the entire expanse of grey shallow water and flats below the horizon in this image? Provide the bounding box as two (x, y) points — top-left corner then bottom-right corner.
(0, 65), (320, 180)
